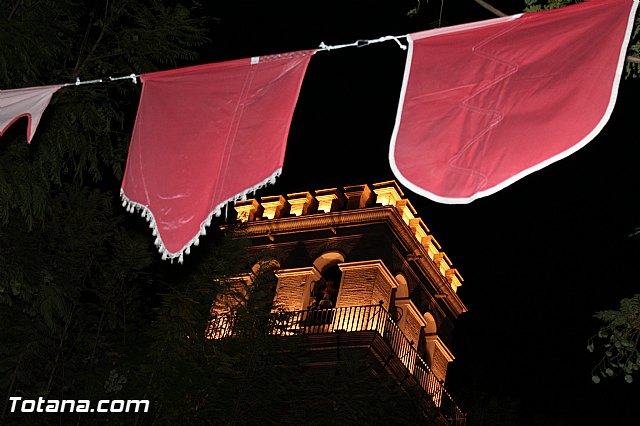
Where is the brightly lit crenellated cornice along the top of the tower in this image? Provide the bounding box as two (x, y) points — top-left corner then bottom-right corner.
(223, 181), (467, 315)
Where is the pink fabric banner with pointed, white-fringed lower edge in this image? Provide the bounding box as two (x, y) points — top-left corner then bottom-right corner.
(121, 51), (314, 261)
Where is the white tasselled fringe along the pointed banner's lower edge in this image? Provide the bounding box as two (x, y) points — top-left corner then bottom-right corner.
(120, 167), (282, 263)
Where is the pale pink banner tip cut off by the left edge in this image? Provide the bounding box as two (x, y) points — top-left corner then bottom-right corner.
(0, 85), (62, 143)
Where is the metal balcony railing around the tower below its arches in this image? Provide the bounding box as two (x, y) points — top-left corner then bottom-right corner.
(207, 305), (466, 426)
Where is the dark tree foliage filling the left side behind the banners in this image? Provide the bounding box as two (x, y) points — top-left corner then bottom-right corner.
(0, 0), (225, 424)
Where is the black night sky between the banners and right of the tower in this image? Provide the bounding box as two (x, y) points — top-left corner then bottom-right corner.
(204, 0), (640, 425)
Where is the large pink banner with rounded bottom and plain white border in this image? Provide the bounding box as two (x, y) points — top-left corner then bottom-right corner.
(389, 0), (637, 204)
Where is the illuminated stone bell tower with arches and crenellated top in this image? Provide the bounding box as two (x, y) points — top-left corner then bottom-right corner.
(211, 181), (466, 424)
